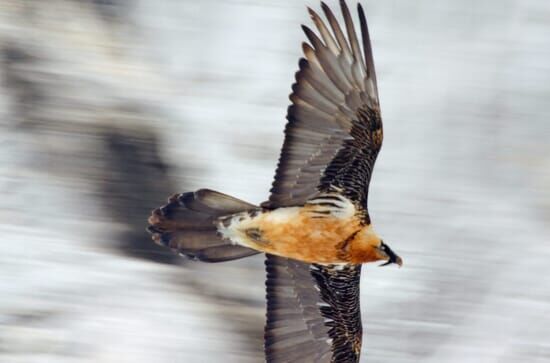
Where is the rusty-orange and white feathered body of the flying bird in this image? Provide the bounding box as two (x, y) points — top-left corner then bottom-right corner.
(217, 193), (381, 264)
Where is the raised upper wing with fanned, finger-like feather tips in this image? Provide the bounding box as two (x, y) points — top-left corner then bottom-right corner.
(265, 1), (383, 211)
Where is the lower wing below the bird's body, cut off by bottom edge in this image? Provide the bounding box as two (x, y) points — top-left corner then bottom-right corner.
(265, 255), (362, 363)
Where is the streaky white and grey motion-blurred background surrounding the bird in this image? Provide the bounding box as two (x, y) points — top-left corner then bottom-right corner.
(0, 0), (550, 363)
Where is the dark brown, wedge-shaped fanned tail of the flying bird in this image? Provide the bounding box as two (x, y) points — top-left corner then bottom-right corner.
(147, 189), (258, 262)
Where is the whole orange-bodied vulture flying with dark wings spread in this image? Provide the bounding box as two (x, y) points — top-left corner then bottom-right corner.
(148, 0), (402, 363)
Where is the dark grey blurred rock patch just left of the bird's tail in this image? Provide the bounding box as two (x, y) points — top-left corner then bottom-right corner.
(100, 123), (184, 262)
